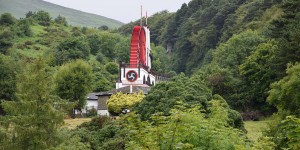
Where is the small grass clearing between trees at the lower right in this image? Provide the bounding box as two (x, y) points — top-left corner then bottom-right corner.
(244, 120), (269, 142)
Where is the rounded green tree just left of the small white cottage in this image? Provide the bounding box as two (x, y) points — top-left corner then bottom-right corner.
(55, 60), (93, 109)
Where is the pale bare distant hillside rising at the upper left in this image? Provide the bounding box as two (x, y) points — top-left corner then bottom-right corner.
(0, 0), (123, 28)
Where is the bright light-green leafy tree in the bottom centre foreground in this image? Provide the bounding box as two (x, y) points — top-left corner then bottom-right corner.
(122, 99), (246, 150)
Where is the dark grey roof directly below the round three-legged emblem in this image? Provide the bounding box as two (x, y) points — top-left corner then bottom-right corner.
(97, 86), (151, 96)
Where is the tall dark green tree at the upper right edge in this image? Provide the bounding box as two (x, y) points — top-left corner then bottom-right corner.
(266, 0), (300, 78)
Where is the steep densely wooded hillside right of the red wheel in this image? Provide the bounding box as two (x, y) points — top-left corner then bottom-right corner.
(119, 0), (300, 114)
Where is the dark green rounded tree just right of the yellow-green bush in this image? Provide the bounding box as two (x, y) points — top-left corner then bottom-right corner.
(135, 73), (212, 120)
